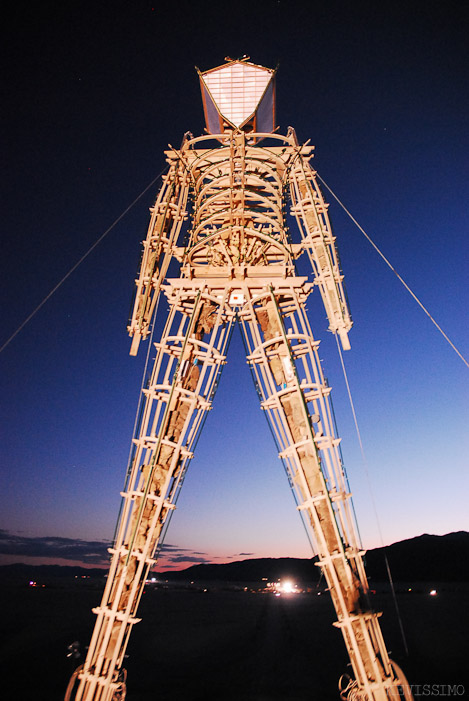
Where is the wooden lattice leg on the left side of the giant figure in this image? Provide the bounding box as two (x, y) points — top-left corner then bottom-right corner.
(65, 281), (234, 701)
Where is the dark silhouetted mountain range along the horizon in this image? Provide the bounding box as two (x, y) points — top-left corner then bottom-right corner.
(0, 531), (469, 583)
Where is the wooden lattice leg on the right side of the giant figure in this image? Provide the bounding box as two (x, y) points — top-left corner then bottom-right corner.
(240, 284), (410, 701)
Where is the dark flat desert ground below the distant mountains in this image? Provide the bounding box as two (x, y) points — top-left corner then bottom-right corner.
(1, 580), (469, 701)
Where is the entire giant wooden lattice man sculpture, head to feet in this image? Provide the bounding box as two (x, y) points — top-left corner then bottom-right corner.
(66, 61), (412, 701)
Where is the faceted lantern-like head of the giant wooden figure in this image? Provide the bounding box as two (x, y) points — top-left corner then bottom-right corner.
(200, 61), (275, 134)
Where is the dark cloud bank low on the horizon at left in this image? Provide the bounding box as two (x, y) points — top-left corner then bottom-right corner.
(0, 529), (210, 565)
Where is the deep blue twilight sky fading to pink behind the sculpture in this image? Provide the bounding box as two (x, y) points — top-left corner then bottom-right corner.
(0, 0), (469, 566)
